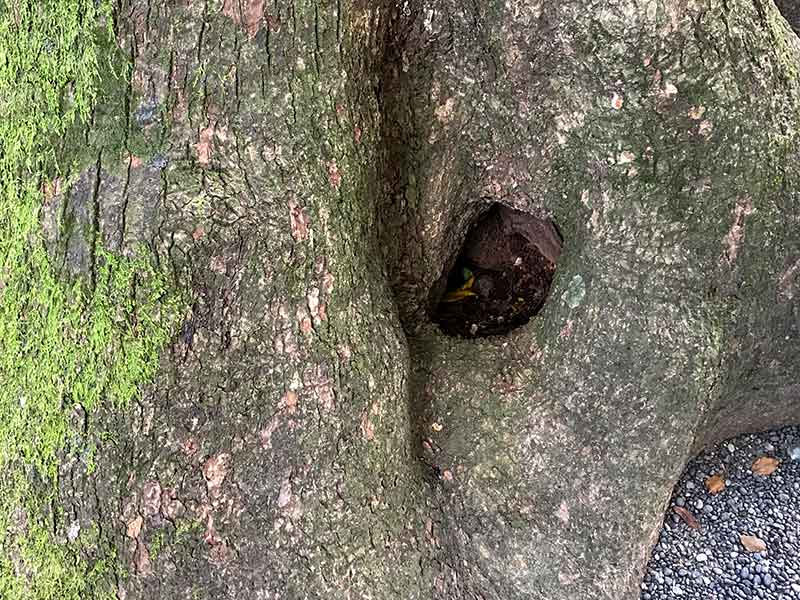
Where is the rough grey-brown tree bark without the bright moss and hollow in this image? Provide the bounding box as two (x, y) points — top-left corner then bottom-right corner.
(46, 0), (800, 600)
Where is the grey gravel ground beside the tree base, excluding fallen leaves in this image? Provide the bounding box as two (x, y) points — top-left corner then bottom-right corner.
(640, 427), (800, 600)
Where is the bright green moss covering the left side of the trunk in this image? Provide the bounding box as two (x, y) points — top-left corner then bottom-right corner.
(0, 0), (182, 600)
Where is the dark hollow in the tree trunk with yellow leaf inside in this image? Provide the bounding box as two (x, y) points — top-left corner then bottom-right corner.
(431, 204), (562, 338)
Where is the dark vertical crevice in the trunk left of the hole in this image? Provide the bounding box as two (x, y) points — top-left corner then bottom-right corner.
(374, 2), (456, 488)
